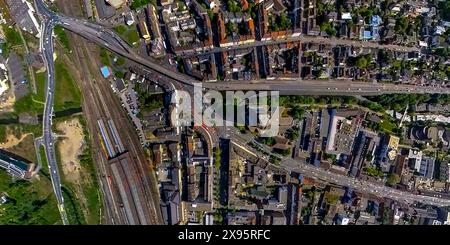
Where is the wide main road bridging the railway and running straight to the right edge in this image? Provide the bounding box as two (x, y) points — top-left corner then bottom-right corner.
(35, 5), (450, 95)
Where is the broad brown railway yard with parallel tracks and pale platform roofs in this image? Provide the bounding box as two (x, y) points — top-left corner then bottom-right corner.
(53, 1), (161, 224)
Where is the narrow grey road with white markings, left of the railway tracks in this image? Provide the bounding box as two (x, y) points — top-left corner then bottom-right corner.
(35, 0), (69, 225)
